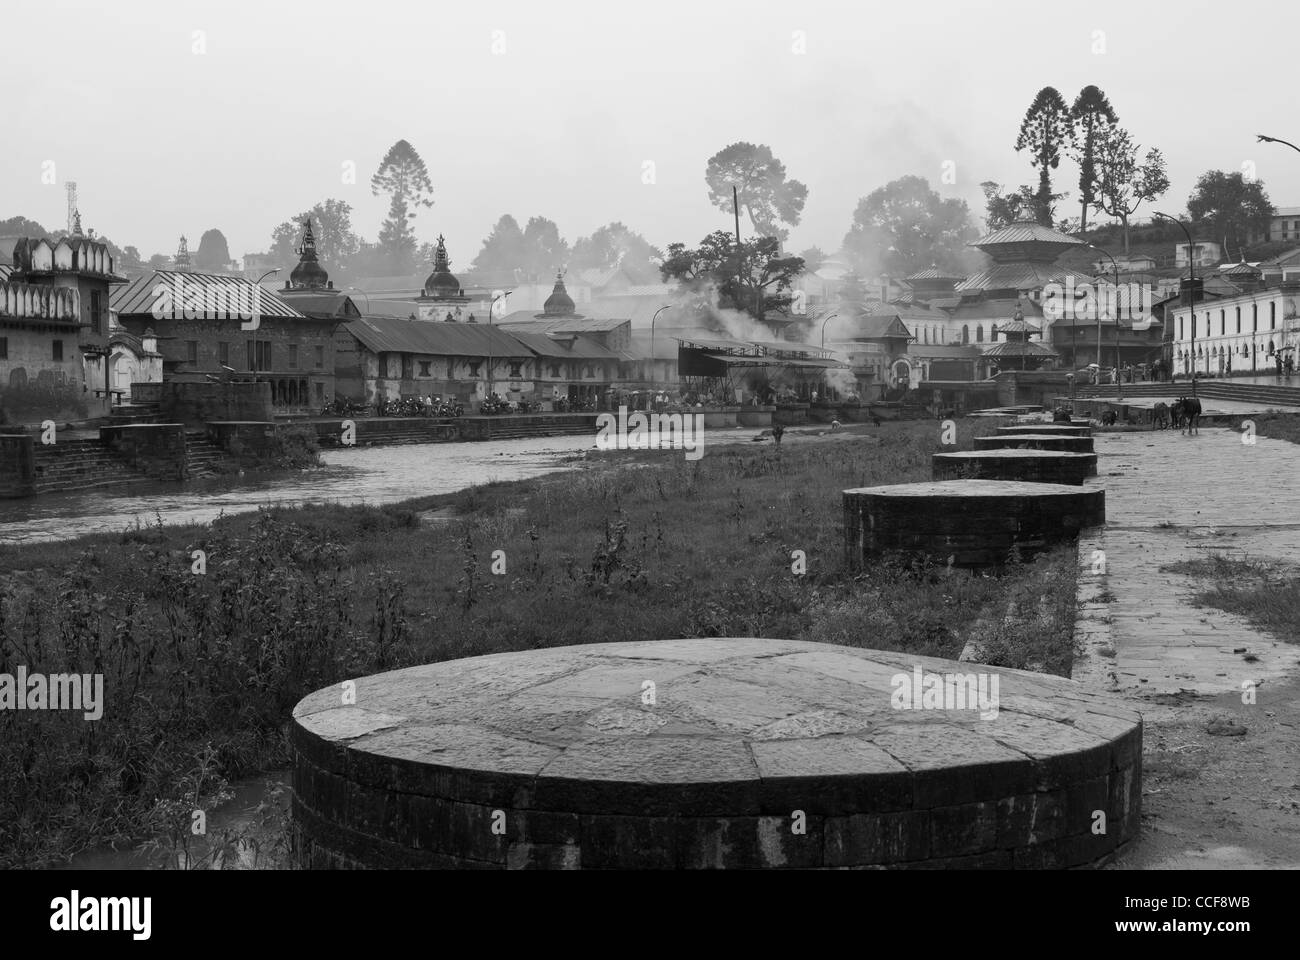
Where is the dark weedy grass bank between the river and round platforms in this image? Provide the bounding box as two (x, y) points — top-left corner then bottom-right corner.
(0, 421), (1076, 866)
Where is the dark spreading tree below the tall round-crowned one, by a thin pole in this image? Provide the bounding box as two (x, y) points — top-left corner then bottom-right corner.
(660, 230), (803, 321)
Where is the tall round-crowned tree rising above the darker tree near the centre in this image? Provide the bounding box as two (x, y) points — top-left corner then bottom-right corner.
(705, 142), (809, 241)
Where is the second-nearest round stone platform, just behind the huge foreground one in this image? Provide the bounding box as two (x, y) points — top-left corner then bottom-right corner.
(844, 480), (1106, 570)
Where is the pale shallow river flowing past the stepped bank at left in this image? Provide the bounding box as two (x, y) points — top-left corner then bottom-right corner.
(0, 434), (595, 544)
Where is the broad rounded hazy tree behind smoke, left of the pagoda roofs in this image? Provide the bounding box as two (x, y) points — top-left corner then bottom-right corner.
(844, 176), (974, 277)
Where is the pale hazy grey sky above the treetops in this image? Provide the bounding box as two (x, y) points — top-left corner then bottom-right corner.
(0, 0), (1300, 269)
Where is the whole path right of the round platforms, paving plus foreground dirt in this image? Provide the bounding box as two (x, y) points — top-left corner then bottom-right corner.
(1074, 428), (1300, 869)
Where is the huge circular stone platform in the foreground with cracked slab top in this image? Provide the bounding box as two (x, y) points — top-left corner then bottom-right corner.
(291, 639), (1141, 869)
